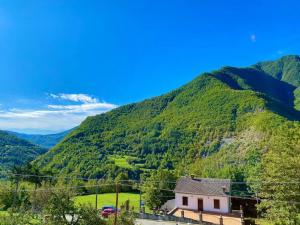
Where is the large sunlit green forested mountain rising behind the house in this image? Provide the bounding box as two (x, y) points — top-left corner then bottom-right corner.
(36, 56), (300, 186)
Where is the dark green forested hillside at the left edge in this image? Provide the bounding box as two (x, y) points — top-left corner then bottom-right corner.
(0, 131), (46, 171)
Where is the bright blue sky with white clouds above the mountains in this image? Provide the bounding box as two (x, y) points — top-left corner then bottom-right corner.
(0, 0), (300, 133)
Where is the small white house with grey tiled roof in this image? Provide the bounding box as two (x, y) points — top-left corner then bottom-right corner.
(174, 177), (231, 213)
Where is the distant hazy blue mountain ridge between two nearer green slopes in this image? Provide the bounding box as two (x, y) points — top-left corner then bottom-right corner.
(9, 129), (72, 149)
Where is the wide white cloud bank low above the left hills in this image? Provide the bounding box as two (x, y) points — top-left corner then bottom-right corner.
(0, 94), (117, 133)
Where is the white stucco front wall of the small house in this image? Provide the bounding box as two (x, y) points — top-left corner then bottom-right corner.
(175, 193), (230, 213)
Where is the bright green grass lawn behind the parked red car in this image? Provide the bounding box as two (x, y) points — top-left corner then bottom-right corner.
(74, 193), (150, 212)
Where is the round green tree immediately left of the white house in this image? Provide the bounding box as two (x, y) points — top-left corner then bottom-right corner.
(142, 170), (176, 209)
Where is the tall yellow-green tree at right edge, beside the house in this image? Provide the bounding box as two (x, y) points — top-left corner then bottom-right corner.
(259, 127), (300, 225)
